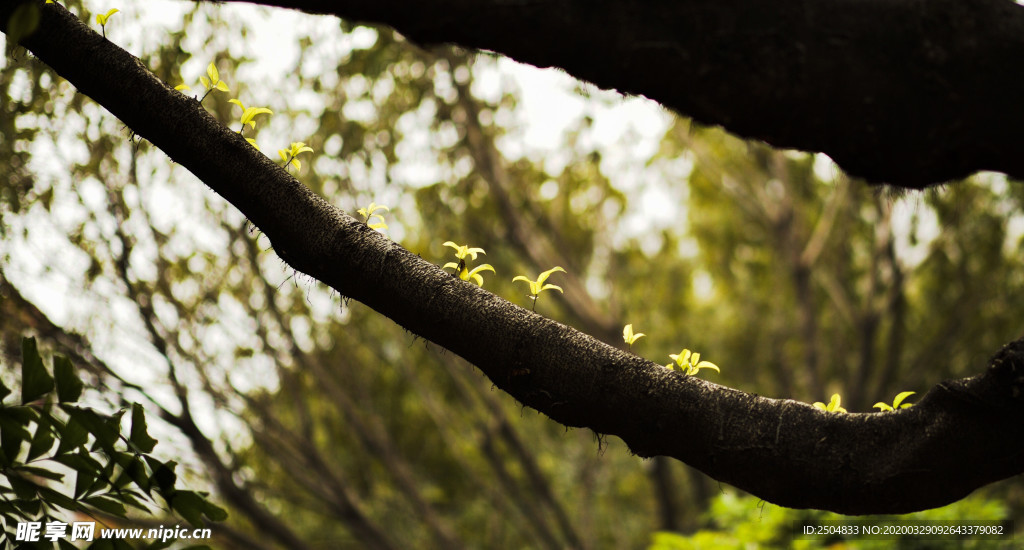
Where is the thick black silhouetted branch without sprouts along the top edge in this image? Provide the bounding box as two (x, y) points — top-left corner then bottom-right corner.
(224, 0), (1024, 187)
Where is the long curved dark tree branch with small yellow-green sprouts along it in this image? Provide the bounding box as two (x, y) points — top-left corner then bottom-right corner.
(6, 0), (1024, 513)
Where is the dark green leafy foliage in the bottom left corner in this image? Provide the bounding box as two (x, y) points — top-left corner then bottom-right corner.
(0, 338), (227, 542)
